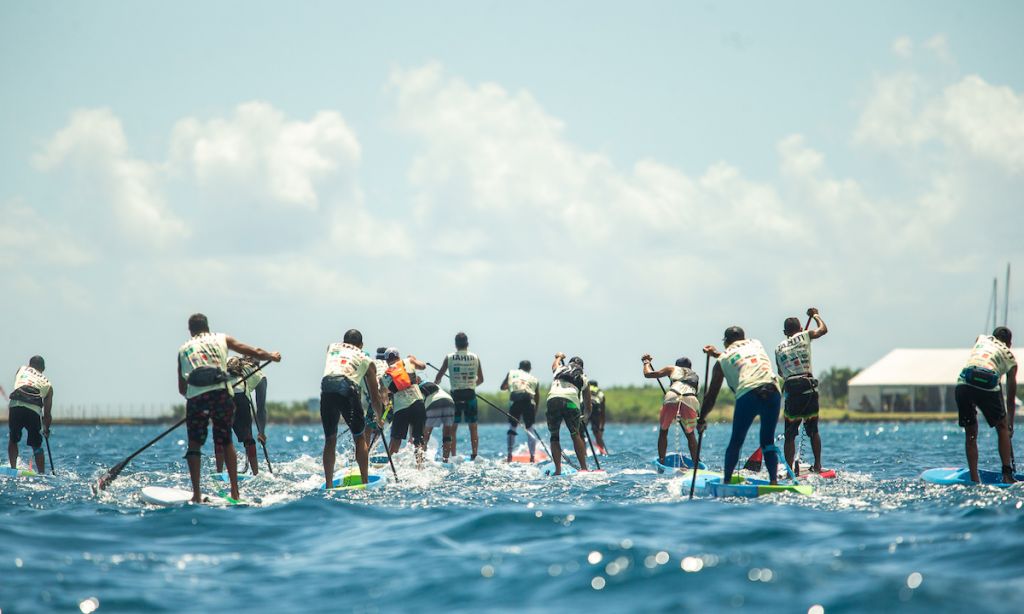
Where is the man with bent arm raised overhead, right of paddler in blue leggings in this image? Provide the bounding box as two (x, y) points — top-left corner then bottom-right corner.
(775, 307), (828, 474)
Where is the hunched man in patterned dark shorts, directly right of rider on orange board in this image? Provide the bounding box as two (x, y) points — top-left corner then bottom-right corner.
(546, 352), (592, 476)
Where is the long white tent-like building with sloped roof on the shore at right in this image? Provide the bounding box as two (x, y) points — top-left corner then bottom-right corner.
(847, 348), (1024, 411)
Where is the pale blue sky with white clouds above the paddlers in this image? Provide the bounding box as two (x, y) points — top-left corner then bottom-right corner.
(0, 2), (1024, 405)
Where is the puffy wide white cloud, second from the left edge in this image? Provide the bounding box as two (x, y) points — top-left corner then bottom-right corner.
(171, 101), (361, 210)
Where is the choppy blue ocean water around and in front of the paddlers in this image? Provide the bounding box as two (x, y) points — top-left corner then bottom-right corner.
(0, 423), (1024, 614)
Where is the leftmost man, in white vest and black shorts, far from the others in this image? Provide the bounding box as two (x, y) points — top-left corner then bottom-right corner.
(7, 356), (53, 475)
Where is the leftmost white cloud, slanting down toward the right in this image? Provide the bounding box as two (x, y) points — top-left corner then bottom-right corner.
(34, 108), (188, 246)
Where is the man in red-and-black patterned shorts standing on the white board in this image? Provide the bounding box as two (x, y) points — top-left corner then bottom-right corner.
(178, 313), (281, 503)
